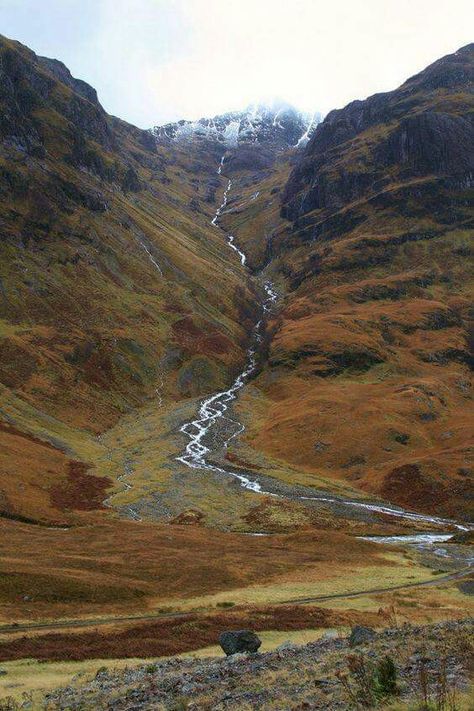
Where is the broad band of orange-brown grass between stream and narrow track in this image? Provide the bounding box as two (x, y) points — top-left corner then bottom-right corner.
(0, 513), (391, 621)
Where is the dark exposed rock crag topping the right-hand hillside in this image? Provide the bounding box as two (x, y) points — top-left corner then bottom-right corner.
(283, 45), (474, 221)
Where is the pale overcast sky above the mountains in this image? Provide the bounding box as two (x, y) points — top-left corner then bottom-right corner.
(0, 0), (474, 128)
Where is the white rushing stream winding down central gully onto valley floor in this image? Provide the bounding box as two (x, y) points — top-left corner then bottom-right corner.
(176, 157), (472, 545)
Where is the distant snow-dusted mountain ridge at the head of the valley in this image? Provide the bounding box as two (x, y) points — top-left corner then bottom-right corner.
(152, 102), (322, 148)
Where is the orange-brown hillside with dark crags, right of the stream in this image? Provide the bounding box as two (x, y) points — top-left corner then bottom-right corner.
(237, 45), (474, 516)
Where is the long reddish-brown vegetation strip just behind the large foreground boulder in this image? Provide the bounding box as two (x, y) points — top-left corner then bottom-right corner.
(0, 605), (380, 661)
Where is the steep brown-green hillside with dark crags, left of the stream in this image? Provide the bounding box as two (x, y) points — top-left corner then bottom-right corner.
(0, 39), (258, 432)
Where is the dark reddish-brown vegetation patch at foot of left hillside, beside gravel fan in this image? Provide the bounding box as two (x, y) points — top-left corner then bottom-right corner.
(49, 461), (112, 511)
